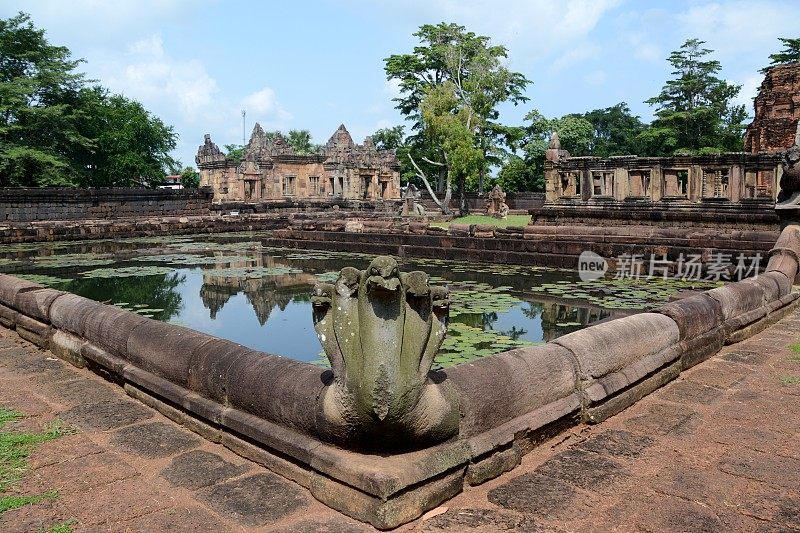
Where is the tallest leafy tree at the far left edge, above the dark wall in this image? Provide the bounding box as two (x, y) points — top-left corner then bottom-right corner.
(0, 13), (94, 186)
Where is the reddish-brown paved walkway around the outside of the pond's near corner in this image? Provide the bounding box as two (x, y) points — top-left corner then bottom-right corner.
(0, 312), (800, 533)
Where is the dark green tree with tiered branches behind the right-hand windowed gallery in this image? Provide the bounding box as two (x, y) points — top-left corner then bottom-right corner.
(639, 39), (747, 155)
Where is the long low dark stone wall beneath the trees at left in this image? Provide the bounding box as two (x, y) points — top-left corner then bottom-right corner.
(0, 187), (212, 222)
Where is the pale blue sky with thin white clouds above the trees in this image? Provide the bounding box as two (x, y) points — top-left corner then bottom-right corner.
(0, 0), (797, 165)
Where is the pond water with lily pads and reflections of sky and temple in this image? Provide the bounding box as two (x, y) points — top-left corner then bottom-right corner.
(0, 233), (713, 368)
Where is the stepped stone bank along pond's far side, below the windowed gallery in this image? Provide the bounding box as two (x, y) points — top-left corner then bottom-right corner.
(264, 219), (779, 268)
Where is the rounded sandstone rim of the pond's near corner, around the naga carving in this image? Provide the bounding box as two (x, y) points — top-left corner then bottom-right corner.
(0, 226), (800, 529)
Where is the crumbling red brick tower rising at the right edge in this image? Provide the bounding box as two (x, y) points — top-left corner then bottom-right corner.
(744, 63), (800, 153)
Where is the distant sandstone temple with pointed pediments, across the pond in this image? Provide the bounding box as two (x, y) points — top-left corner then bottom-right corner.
(195, 124), (400, 202)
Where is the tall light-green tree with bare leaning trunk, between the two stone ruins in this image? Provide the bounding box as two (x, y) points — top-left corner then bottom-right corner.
(384, 22), (530, 213)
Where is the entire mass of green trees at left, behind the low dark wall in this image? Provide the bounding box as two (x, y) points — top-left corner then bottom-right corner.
(0, 13), (177, 186)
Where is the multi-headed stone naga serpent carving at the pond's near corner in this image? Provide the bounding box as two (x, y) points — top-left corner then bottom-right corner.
(311, 256), (459, 449)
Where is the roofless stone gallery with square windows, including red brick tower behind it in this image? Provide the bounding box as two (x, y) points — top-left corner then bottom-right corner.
(536, 63), (800, 227)
